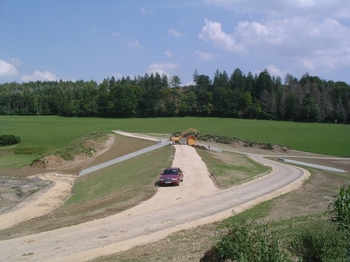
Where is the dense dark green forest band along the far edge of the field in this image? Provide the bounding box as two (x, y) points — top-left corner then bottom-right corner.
(0, 68), (350, 124)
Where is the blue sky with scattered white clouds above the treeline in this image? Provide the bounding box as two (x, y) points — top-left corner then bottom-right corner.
(0, 0), (350, 85)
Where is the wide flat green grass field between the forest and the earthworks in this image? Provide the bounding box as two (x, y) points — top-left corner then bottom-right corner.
(0, 116), (350, 160)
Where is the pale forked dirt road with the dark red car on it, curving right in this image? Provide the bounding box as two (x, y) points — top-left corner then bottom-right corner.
(0, 146), (309, 261)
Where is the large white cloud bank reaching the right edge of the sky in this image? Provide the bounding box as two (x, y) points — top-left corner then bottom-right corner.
(199, 17), (350, 70)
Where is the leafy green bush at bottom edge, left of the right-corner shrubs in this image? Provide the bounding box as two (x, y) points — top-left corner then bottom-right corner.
(215, 219), (288, 262)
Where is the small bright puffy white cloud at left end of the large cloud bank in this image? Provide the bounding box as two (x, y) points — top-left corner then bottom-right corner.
(199, 19), (244, 53)
